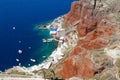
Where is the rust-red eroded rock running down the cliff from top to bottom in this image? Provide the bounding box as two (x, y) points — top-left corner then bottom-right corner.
(58, 0), (115, 79)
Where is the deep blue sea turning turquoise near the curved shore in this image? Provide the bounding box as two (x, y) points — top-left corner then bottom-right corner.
(0, 0), (74, 70)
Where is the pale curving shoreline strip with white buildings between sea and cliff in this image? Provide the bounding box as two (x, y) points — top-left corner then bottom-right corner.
(1, 16), (77, 78)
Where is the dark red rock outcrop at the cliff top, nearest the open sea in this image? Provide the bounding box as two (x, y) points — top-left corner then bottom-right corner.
(64, 1), (92, 26)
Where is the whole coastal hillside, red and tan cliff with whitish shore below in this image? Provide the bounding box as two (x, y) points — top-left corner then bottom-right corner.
(3, 0), (120, 80)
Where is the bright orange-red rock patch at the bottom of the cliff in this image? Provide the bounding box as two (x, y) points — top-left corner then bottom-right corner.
(59, 54), (94, 79)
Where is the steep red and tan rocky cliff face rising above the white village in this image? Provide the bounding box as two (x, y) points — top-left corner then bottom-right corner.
(56, 0), (120, 80)
